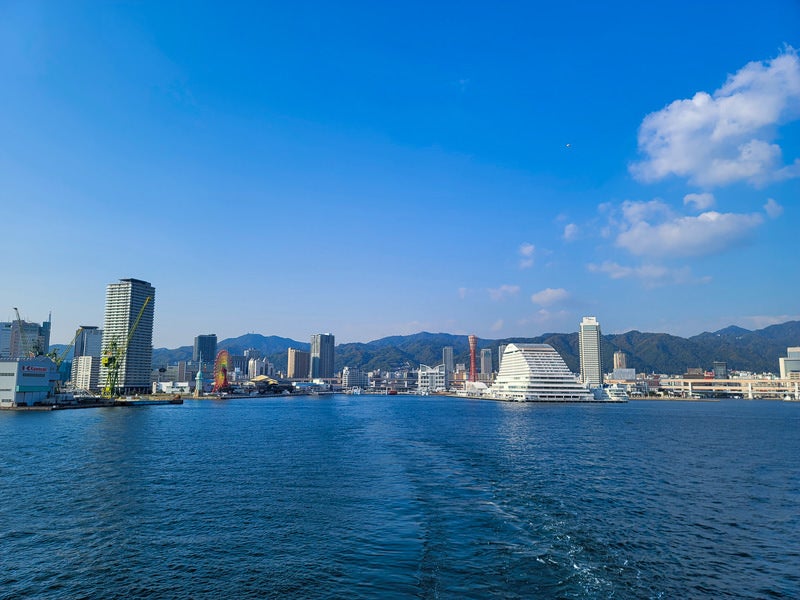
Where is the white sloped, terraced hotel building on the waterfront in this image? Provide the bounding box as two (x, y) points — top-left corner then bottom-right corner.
(489, 344), (594, 402)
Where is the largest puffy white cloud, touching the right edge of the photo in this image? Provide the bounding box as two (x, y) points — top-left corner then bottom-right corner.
(630, 47), (800, 186)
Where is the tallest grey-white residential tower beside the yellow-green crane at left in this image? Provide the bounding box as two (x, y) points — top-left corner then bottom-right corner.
(100, 279), (156, 394)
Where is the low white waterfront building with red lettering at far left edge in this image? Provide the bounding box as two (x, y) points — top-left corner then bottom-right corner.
(0, 356), (59, 408)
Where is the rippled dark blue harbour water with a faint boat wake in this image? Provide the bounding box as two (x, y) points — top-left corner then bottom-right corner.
(0, 396), (800, 598)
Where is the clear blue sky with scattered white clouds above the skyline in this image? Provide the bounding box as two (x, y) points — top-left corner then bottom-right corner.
(0, 0), (800, 347)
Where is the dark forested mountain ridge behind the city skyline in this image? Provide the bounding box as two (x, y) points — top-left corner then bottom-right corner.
(145, 321), (800, 374)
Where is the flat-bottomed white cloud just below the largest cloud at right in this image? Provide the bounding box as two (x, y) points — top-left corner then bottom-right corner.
(616, 200), (764, 257)
